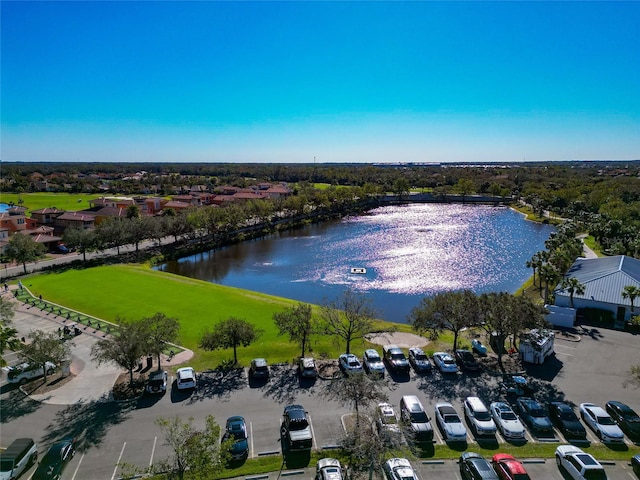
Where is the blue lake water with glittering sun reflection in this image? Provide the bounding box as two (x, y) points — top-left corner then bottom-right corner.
(158, 204), (554, 322)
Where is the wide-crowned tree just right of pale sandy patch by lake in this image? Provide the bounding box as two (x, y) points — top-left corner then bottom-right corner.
(409, 290), (481, 351)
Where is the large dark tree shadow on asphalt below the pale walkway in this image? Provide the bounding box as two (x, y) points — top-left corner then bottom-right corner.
(43, 394), (135, 451)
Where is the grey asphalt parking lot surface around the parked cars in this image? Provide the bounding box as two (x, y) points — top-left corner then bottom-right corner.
(2, 314), (640, 479)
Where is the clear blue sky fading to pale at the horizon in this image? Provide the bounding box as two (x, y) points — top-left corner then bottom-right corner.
(0, 1), (640, 162)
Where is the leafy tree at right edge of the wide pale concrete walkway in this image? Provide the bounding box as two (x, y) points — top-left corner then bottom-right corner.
(91, 318), (148, 385)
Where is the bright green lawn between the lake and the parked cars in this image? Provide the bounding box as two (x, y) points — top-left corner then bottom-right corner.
(23, 265), (410, 370)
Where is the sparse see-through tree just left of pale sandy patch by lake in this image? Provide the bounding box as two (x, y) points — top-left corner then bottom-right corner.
(321, 289), (375, 353)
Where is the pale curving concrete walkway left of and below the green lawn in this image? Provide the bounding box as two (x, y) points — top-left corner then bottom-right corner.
(2, 286), (193, 405)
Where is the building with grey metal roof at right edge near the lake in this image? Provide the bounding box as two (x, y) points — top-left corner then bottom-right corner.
(553, 255), (640, 328)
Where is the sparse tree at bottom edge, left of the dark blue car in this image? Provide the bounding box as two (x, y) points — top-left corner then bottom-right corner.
(153, 415), (228, 480)
